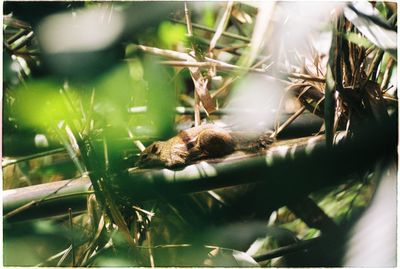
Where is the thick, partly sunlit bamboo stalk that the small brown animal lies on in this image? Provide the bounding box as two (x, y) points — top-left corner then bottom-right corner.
(3, 115), (397, 222)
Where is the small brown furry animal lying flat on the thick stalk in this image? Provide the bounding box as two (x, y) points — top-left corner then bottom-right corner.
(136, 124), (272, 167)
